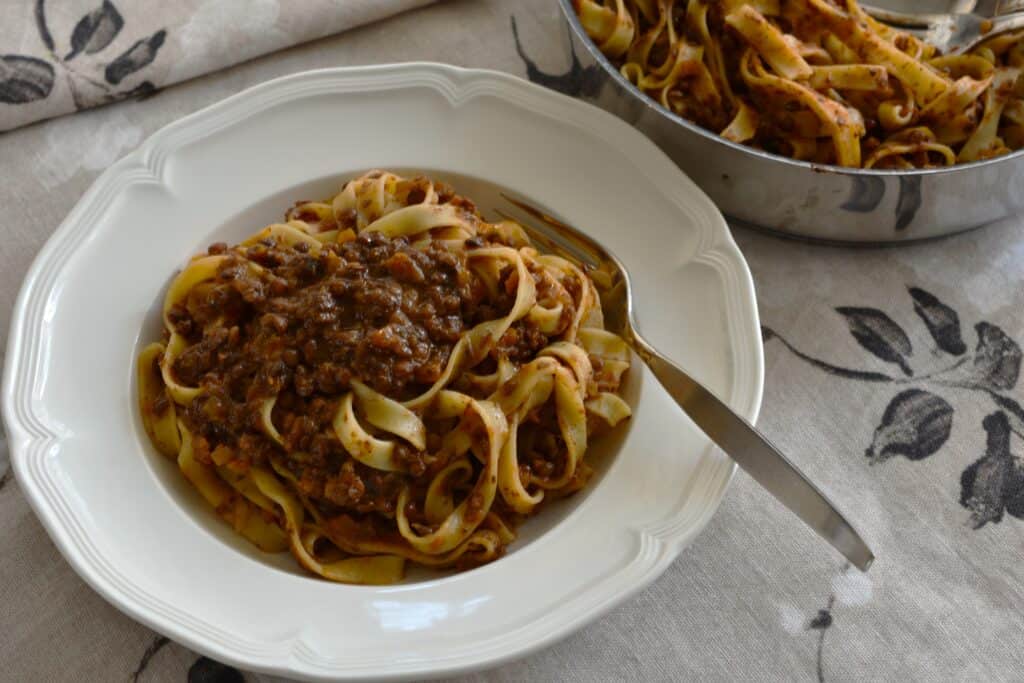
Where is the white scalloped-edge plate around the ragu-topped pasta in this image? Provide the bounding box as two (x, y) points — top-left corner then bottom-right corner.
(3, 63), (763, 680)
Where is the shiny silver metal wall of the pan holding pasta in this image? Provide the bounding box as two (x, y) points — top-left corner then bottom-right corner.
(551, 0), (1024, 244)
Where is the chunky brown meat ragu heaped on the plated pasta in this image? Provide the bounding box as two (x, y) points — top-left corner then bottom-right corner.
(169, 180), (575, 518)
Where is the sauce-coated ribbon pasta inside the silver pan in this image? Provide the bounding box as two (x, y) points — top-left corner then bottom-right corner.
(573, 0), (1024, 169)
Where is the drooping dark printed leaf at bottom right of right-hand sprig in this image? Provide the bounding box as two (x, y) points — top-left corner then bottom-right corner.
(961, 412), (1024, 529)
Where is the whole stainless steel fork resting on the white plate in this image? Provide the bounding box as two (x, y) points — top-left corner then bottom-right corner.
(499, 195), (874, 571)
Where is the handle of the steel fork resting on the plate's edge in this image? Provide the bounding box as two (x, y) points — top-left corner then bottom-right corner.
(627, 330), (874, 571)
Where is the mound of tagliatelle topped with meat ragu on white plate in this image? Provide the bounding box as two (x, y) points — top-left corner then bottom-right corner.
(138, 171), (630, 584)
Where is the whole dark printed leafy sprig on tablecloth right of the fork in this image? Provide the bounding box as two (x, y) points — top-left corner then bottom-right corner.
(762, 287), (1024, 532)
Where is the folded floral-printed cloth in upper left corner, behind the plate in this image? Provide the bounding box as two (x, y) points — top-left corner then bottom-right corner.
(0, 0), (434, 131)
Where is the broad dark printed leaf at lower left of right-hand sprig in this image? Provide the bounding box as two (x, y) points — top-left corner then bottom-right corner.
(864, 389), (953, 464)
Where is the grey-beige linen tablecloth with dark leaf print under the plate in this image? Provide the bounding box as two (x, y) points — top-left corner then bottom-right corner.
(0, 0), (1024, 681)
